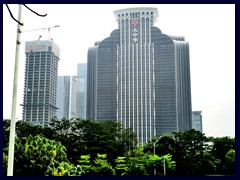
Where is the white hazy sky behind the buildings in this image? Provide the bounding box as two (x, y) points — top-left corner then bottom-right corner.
(3, 4), (235, 137)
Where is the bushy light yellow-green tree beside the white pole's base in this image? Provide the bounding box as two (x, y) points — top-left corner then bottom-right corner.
(4, 135), (68, 176)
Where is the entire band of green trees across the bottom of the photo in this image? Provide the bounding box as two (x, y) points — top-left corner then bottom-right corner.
(3, 118), (235, 176)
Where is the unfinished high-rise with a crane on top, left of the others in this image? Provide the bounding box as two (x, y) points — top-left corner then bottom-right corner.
(22, 41), (60, 125)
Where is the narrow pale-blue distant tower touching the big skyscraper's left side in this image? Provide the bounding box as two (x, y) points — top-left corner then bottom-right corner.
(77, 63), (87, 119)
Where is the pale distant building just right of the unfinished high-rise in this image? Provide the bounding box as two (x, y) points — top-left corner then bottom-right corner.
(57, 76), (79, 119)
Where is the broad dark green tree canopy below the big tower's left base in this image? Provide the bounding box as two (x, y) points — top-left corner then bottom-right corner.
(50, 118), (136, 165)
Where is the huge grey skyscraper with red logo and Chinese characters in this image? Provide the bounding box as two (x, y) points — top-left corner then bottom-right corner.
(87, 8), (192, 144)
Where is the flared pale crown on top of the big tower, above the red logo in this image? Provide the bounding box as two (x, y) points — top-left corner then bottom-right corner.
(114, 7), (158, 24)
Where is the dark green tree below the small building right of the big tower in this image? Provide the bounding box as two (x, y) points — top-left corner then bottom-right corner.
(173, 129), (208, 175)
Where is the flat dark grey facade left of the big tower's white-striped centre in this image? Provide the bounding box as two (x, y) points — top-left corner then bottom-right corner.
(95, 31), (119, 121)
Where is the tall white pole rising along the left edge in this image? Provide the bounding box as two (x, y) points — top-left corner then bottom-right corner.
(7, 4), (22, 176)
